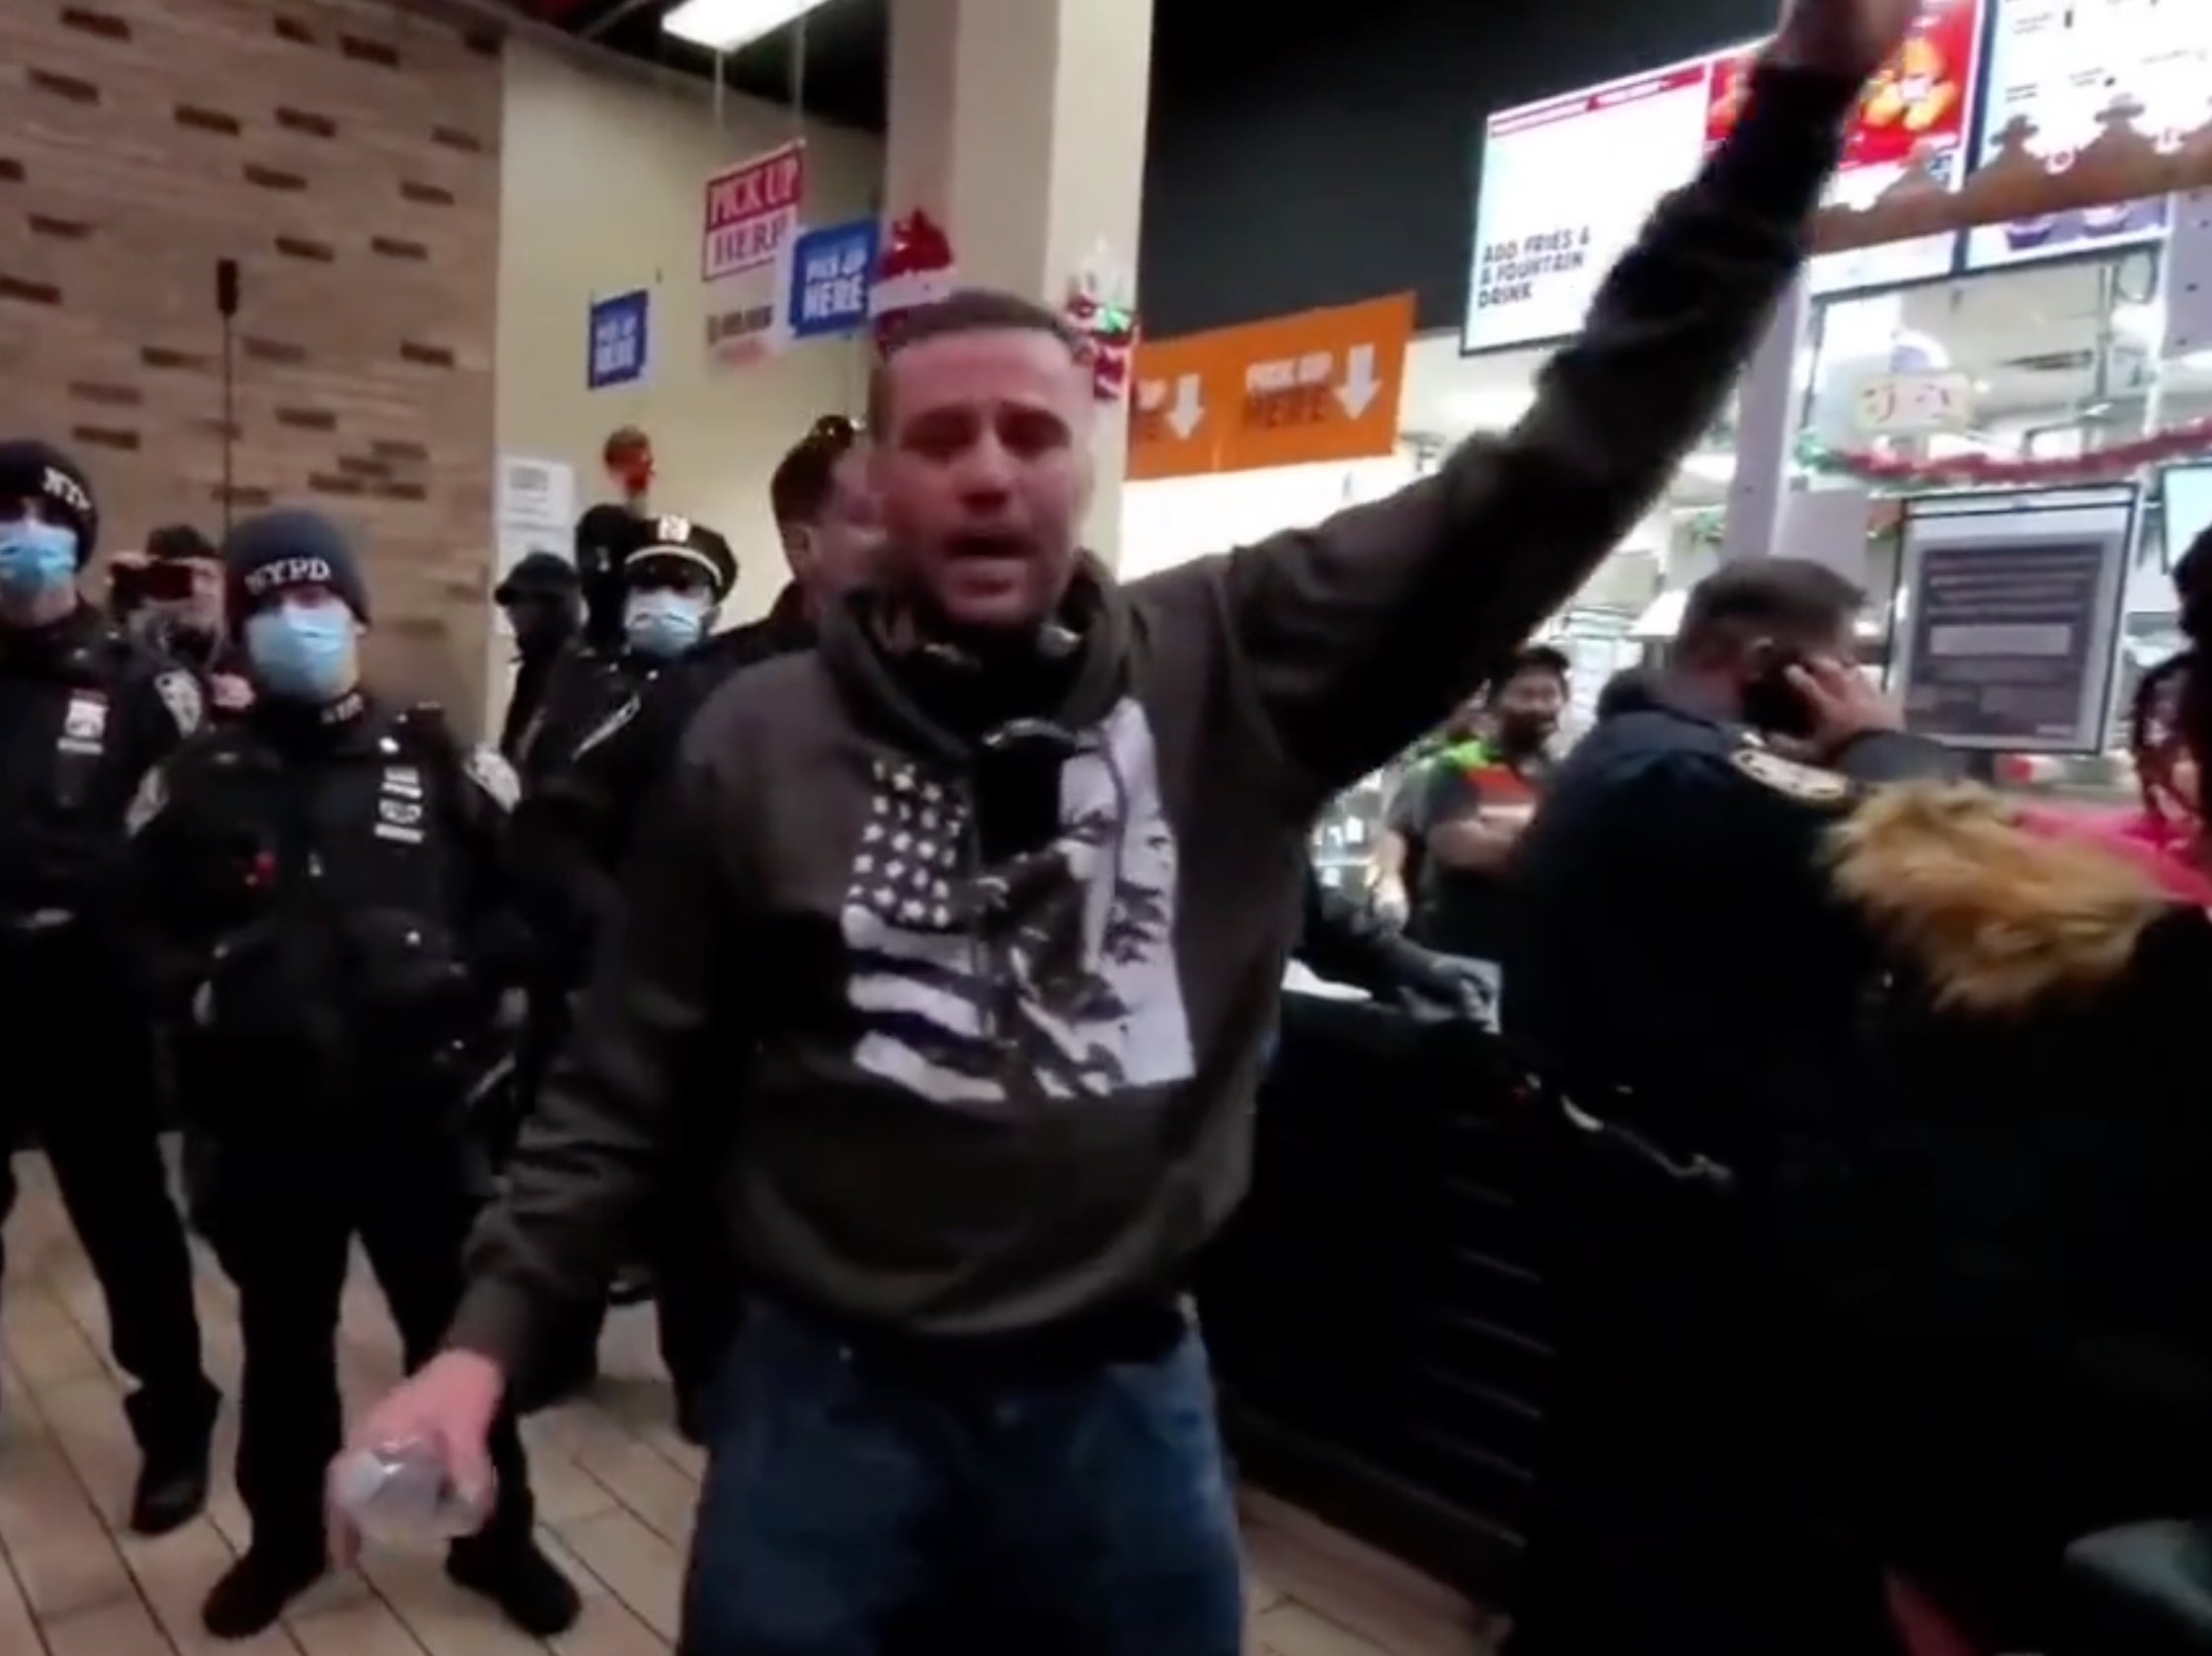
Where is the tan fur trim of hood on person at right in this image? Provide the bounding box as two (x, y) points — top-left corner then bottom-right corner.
(1832, 783), (2187, 1012)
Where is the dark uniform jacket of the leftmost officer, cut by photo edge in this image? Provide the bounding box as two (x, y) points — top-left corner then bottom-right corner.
(0, 603), (205, 946)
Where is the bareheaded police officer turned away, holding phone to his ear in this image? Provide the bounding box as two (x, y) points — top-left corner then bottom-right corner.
(1502, 557), (1951, 1656)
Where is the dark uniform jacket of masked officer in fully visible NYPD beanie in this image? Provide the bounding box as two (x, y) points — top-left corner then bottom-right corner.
(130, 694), (522, 1112)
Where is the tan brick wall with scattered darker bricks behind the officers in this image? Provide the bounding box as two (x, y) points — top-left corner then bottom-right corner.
(0, 0), (502, 723)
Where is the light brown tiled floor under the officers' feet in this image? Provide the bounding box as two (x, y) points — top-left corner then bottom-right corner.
(0, 1158), (1489, 1656)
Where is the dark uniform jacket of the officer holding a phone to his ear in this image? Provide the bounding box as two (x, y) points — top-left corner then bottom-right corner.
(1504, 683), (1957, 1160)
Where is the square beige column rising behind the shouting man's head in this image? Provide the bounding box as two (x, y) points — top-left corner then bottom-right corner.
(885, 0), (1152, 562)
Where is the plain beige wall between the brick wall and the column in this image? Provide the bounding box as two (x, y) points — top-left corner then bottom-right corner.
(498, 39), (883, 641)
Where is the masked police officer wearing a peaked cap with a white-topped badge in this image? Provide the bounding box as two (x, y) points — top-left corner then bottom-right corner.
(515, 506), (737, 1419)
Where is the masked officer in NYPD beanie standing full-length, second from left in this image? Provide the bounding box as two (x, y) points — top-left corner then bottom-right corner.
(132, 511), (578, 1638)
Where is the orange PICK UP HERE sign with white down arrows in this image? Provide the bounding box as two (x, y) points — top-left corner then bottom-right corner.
(1128, 294), (1413, 482)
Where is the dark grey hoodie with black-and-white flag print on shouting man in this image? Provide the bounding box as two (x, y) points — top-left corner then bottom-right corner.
(453, 71), (1854, 1364)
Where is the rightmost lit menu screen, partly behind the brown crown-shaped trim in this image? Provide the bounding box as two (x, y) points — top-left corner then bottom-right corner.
(1966, 0), (2212, 270)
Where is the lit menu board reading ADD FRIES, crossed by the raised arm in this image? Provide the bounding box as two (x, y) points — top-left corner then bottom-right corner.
(1460, 0), (1999, 352)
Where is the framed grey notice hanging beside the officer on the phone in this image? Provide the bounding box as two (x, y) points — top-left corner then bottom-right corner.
(1891, 489), (2137, 753)
